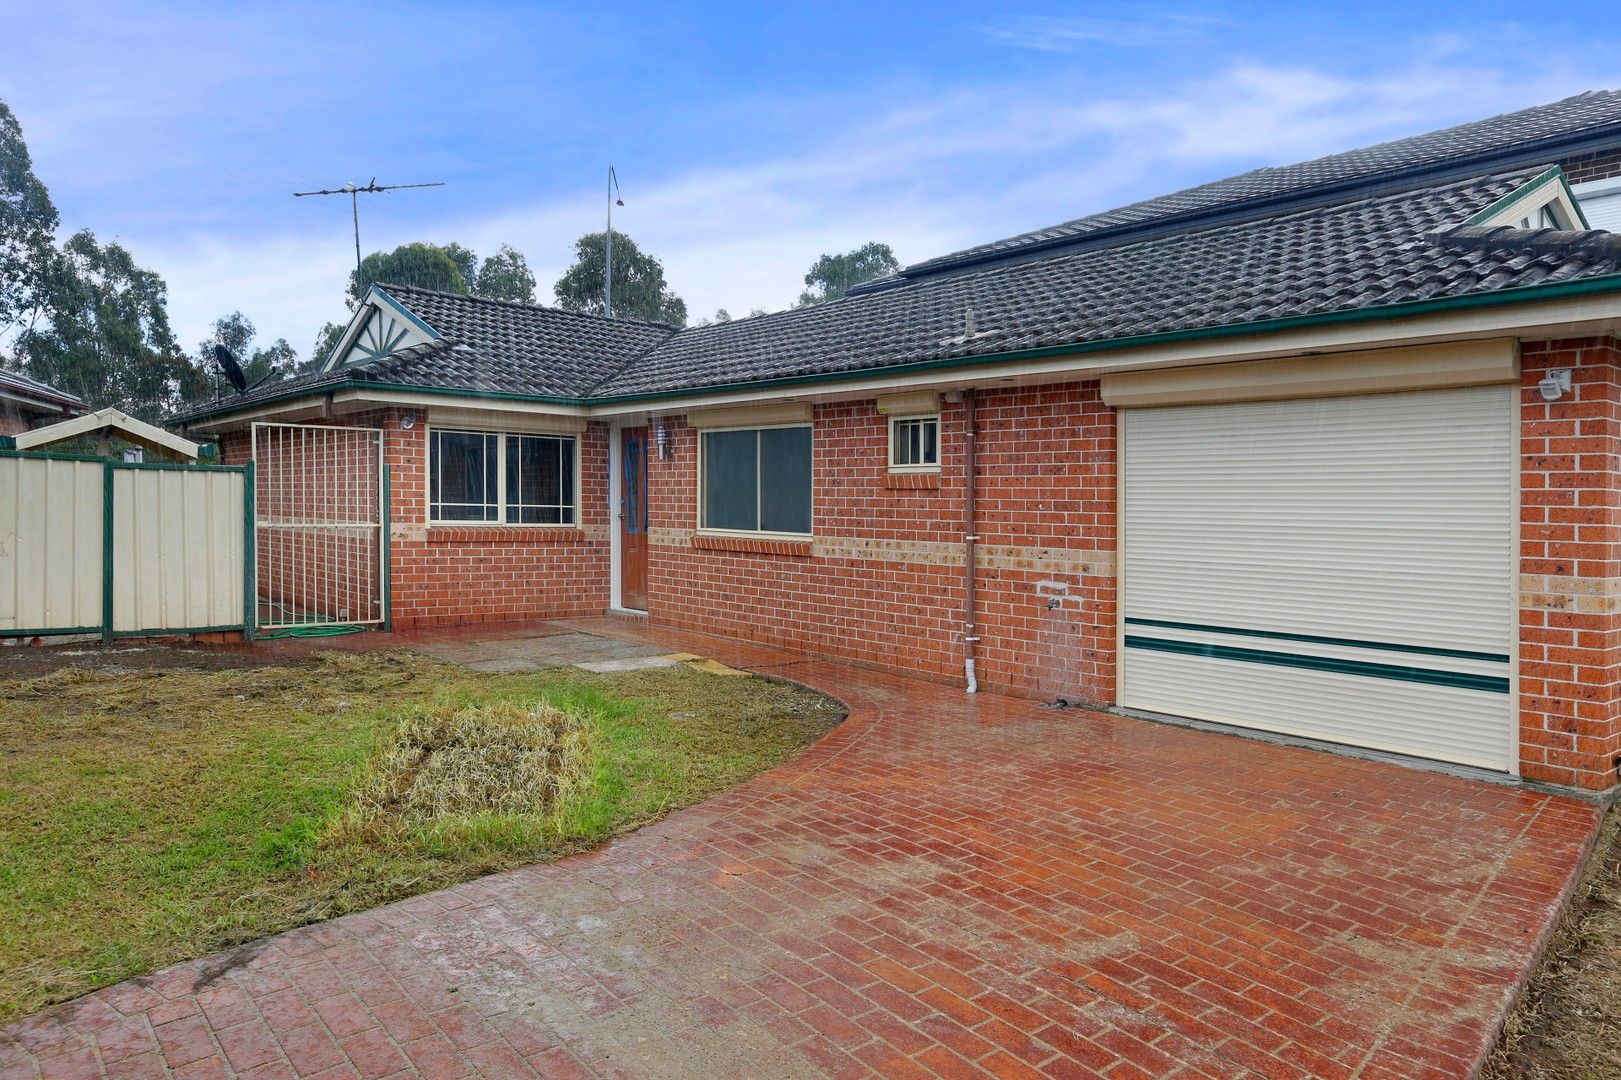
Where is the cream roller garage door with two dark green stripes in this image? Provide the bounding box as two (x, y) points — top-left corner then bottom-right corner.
(1120, 386), (1517, 770)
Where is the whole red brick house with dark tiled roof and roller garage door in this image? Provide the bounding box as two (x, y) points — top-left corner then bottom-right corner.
(183, 92), (1621, 790)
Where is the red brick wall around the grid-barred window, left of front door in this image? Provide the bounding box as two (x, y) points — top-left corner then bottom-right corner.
(220, 410), (608, 629)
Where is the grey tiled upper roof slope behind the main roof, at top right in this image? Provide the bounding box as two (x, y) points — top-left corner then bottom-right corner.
(883, 91), (1621, 284)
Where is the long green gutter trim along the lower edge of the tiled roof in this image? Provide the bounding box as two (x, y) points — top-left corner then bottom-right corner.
(193, 262), (1621, 423)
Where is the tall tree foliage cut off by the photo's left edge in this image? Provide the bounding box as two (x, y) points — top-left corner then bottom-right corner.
(0, 101), (57, 334)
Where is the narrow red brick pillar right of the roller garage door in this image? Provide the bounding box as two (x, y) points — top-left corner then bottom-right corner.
(1520, 337), (1621, 790)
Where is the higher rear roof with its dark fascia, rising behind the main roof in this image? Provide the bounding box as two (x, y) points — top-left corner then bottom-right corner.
(846, 89), (1621, 295)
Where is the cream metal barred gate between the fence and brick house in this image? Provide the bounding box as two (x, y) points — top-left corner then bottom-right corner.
(253, 423), (389, 631)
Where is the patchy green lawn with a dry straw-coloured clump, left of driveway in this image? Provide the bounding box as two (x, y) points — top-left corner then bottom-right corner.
(0, 654), (843, 1018)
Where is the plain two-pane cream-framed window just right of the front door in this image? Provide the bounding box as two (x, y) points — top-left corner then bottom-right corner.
(699, 426), (811, 534)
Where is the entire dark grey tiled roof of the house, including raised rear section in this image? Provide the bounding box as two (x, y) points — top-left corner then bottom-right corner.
(182, 91), (1621, 420)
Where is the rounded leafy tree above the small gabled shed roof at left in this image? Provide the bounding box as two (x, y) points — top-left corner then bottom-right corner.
(16, 229), (203, 420)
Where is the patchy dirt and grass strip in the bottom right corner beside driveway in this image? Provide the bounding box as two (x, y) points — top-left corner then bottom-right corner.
(1482, 808), (1621, 1080)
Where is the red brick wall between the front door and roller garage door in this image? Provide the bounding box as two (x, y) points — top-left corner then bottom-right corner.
(648, 383), (1115, 702)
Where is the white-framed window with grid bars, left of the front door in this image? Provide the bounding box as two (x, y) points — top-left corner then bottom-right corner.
(428, 430), (575, 525)
